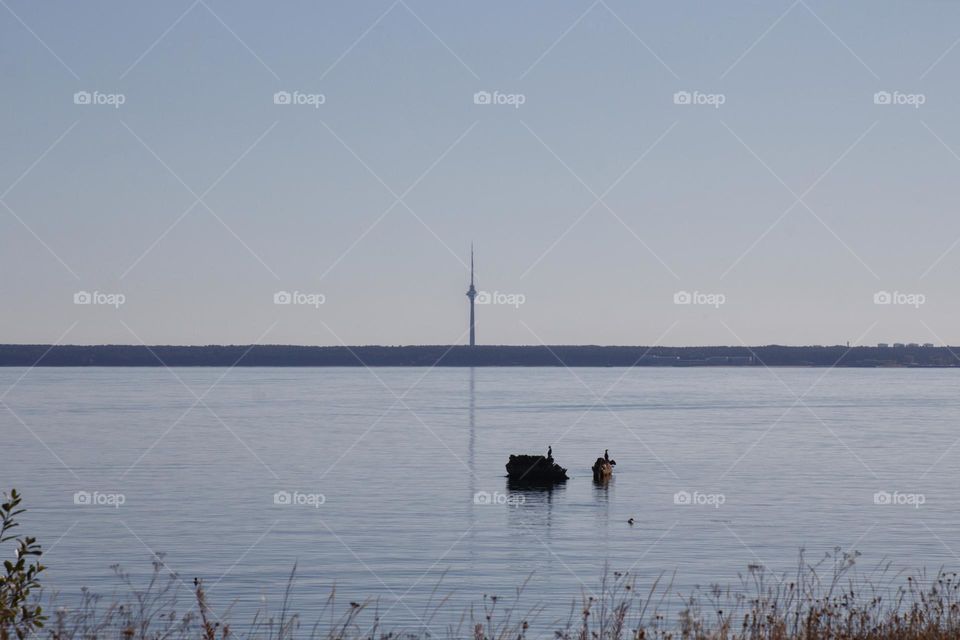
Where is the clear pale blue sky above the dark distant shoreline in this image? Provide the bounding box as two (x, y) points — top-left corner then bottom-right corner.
(0, 0), (960, 345)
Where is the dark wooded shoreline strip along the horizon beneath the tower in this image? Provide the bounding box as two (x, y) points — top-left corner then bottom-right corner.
(0, 344), (960, 368)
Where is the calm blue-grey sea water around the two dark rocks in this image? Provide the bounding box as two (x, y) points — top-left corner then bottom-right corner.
(0, 368), (960, 624)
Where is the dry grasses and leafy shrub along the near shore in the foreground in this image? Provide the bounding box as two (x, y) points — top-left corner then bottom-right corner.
(0, 491), (960, 640)
